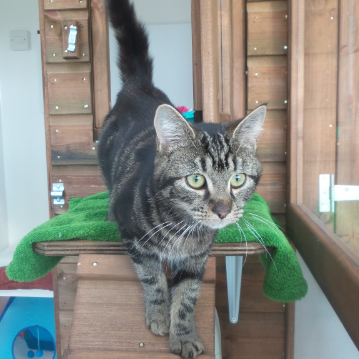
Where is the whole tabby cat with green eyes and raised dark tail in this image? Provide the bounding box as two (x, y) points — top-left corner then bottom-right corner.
(99, 0), (266, 358)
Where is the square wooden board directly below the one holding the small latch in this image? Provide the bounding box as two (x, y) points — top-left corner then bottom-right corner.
(47, 63), (92, 115)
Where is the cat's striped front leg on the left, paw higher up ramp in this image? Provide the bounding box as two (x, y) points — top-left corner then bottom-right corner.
(131, 250), (170, 335)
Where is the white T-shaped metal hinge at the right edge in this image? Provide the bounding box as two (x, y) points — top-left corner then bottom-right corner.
(319, 174), (359, 213)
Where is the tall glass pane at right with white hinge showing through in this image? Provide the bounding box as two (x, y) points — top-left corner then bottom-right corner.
(303, 0), (359, 257)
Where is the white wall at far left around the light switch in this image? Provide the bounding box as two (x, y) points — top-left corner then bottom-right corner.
(0, 0), (49, 256)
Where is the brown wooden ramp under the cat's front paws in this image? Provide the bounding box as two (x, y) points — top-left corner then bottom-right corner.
(65, 255), (215, 358)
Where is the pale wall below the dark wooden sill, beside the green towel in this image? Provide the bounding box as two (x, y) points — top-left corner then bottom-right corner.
(294, 254), (359, 359)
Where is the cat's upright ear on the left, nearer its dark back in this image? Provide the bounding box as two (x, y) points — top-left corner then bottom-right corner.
(154, 105), (196, 153)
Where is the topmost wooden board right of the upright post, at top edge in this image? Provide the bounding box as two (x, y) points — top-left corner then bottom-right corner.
(247, 1), (288, 56)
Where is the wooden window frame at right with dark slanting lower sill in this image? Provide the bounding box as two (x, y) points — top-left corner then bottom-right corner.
(287, 0), (359, 348)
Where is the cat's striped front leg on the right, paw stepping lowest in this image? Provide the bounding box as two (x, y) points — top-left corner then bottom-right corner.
(169, 255), (208, 358)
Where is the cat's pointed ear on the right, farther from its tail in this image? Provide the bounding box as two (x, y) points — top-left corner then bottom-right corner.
(232, 105), (267, 151)
